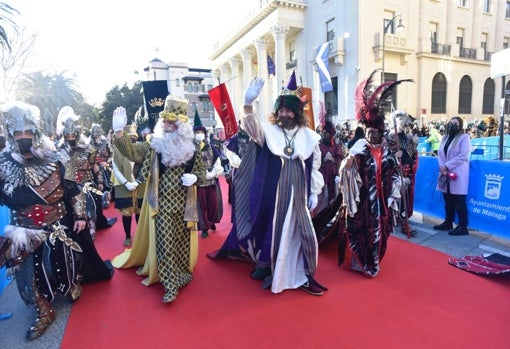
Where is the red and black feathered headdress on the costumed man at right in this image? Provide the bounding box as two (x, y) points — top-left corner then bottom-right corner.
(354, 70), (413, 131)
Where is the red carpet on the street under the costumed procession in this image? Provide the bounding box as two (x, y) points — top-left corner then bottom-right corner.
(62, 178), (510, 349)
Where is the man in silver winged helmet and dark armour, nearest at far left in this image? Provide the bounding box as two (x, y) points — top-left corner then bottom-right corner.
(0, 102), (86, 340)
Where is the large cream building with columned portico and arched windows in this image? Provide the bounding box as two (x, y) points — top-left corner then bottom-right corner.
(210, 0), (510, 128)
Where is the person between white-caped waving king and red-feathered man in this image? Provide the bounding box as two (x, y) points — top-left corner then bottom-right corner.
(312, 121), (345, 244)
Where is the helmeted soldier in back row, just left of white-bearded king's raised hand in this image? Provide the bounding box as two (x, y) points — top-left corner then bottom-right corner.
(89, 124), (113, 208)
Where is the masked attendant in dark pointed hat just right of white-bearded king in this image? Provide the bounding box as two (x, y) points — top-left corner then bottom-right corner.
(193, 113), (223, 239)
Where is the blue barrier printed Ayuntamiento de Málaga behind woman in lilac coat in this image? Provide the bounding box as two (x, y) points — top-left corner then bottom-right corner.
(414, 156), (510, 240)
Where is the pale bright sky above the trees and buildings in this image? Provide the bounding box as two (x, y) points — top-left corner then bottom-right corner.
(8, 0), (255, 105)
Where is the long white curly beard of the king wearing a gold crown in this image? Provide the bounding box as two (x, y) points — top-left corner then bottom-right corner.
(151, 123), (195, 167)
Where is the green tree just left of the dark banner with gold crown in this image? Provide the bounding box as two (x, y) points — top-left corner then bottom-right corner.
(98, 81), (143, 132)
